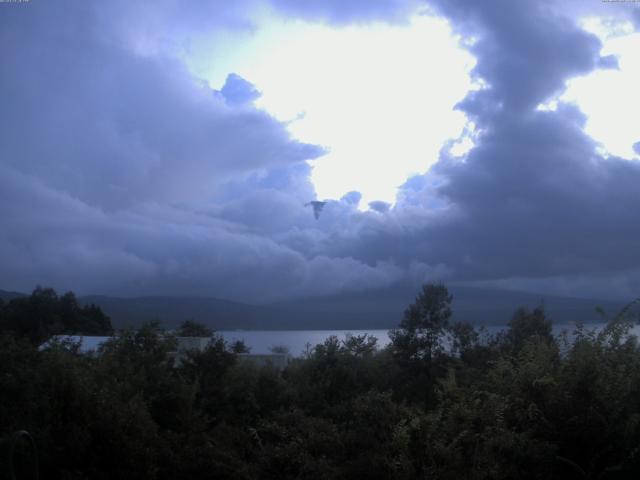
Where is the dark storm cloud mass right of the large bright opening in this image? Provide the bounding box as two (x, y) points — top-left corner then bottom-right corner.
(318, 1), (640, 295)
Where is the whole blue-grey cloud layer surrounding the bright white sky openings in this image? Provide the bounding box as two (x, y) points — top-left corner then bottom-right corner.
(0, 0), (640, 301)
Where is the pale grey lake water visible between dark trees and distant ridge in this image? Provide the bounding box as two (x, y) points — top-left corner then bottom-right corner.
(218, 323), (640, 356)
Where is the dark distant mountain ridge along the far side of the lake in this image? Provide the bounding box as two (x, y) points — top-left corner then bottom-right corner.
(0, 286), (624, 330)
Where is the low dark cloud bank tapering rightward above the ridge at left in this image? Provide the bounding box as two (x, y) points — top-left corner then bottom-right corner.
(0, 163), (401, 302)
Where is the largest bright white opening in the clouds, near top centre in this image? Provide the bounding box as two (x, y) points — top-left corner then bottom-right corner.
(189, 16), (475, 208)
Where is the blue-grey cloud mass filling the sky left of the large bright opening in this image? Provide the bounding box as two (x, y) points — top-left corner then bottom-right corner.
(0, 1), (410, 301)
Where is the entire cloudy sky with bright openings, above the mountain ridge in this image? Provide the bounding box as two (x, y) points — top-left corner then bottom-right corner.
(0, 0), (640, 303)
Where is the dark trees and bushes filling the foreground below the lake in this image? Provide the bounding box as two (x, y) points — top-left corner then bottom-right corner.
(0, 285), (640, 480)
